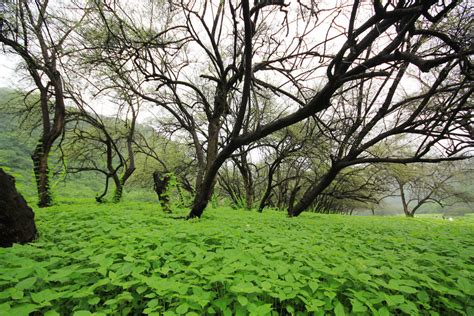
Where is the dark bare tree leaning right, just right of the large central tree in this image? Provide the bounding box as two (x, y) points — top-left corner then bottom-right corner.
(291, 57), (473, 216)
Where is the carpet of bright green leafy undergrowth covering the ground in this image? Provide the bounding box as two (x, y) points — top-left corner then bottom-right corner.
(0, 203), (474, 316)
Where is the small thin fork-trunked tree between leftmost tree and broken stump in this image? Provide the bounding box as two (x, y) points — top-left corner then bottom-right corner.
(63, 91), (141, 202)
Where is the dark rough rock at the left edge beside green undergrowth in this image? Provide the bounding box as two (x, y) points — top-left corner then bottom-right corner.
(0, 168), (38, 247)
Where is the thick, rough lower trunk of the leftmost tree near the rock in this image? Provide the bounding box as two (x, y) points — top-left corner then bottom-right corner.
(31, 140), (53, 207)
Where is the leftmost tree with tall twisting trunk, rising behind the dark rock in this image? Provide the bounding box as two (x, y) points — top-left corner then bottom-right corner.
(0, 0), (80, 207)
